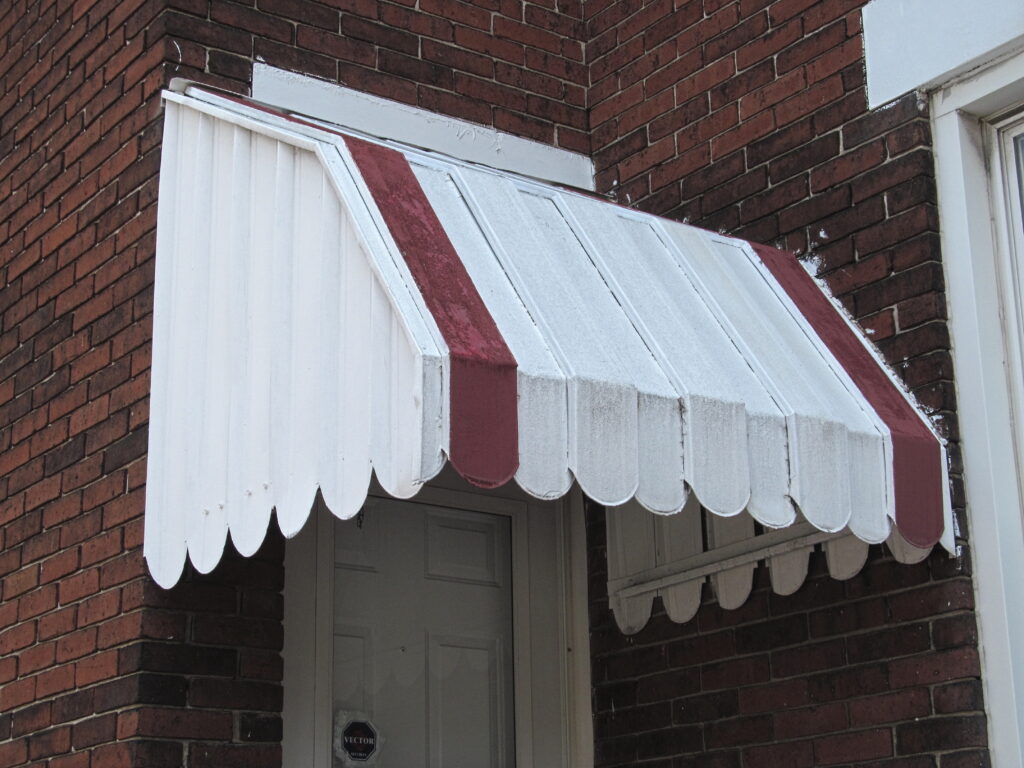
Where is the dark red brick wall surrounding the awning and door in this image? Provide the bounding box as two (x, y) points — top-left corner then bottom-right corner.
(0, 0), (986, 768)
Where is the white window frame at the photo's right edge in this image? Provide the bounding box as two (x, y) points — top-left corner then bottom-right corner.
(932, 52), (1024, 766)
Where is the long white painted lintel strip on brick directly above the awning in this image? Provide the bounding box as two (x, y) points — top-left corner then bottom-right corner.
(252, 62), (595, 191)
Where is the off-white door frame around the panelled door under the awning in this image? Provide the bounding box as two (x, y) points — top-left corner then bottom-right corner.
(283, 471), (594, 768)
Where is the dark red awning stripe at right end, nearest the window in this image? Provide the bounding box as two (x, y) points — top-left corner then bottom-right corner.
(751, 243), (943, 548)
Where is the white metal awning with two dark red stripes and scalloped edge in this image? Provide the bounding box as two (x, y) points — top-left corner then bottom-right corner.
(145, 89), (953, 614)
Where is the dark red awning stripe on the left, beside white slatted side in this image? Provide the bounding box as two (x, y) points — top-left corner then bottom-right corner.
(345, 136), (519, 487)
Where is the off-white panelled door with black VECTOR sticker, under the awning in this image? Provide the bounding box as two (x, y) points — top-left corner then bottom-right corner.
(333, 500), (515, 768)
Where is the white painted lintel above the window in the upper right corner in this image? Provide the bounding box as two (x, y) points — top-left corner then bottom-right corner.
(863, 0), (1024, 108)
